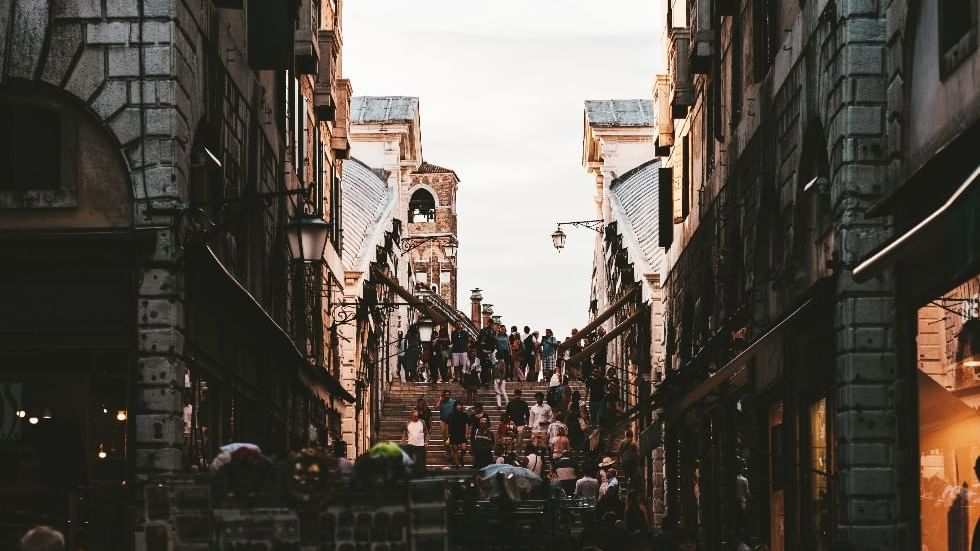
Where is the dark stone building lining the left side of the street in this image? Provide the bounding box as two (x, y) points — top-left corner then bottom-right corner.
(0, 0), (353, 549)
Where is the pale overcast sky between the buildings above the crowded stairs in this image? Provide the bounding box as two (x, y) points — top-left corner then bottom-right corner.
(343, 0), (663, 337)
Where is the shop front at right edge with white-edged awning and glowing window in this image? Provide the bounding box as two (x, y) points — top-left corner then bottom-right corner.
(854, 119), (980, 551)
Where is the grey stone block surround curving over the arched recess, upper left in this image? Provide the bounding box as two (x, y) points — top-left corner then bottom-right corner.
(0, 0), (180, 225)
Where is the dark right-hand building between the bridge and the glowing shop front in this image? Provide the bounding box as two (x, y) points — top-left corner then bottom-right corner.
(654, 0), (900, 550)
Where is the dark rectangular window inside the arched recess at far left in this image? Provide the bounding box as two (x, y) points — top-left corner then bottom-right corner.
(0, 90), (77, 208)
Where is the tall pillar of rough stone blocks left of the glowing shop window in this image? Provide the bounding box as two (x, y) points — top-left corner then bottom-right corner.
(825, 0), (904, 550)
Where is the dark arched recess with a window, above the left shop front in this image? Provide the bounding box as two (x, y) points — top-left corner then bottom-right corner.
(0, 79), (134, 229)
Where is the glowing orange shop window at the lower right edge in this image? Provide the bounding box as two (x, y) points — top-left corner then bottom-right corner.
(916, 274), (980, 549)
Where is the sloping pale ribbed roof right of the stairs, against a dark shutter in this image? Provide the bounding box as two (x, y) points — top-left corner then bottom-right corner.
(609, 159), (669, 273)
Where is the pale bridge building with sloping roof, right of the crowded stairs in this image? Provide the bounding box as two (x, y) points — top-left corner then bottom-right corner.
(566, 99), (665, 522)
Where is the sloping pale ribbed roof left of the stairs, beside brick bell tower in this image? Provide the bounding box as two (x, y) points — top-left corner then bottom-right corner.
(340, 158), (388, 270)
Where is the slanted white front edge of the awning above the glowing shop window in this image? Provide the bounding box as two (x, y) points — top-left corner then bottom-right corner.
(853, 162), (980, 283)
